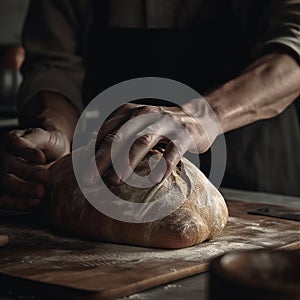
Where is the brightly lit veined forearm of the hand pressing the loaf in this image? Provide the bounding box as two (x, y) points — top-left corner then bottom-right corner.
(205, 53), (300, 132)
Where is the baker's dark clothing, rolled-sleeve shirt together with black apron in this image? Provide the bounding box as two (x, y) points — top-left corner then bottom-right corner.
(19, 0), (300, 195)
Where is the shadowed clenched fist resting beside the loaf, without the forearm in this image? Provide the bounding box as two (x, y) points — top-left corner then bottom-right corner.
(0, 128), (70, 209)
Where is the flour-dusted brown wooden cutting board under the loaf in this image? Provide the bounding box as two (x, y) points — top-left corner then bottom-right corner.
(0, 201), (300, 299)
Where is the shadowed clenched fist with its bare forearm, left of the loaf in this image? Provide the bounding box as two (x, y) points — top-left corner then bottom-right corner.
(0, 91), (79, 209)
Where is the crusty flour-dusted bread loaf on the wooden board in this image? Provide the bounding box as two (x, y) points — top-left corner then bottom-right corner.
(42, 150), (228, 249)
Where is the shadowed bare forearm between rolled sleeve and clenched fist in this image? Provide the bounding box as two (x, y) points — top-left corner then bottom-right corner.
(20, 91), (79, 142)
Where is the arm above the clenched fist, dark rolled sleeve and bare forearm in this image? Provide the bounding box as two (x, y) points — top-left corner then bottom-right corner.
(18, 0), (88, 127)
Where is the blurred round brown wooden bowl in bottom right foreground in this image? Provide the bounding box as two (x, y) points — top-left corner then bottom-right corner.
(209, 250), (300, 300)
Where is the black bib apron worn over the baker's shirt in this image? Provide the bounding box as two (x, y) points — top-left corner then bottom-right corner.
(84, 0), (300, 196)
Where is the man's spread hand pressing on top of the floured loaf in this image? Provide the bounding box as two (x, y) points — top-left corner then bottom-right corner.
(84, 99), (221, 185)
